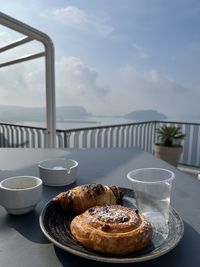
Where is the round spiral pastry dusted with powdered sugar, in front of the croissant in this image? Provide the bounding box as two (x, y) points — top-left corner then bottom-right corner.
(70, 205), (152, 255)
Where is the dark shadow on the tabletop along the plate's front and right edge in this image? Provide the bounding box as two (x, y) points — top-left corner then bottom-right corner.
(54, 223), (200, 267)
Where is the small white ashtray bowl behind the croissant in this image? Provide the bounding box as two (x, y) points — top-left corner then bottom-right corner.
(38, 158), (78, 186)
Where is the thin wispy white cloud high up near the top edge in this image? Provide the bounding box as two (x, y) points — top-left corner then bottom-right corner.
(41, 6), (114, 37)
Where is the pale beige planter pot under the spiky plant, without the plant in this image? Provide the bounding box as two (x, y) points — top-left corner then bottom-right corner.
(154, 145), (183, 166)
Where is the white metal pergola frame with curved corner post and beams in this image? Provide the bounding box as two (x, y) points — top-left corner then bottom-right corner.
(0, 12), (56, 148)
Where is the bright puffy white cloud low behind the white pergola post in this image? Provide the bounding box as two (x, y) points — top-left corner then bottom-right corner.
(0, 57), (109, 112)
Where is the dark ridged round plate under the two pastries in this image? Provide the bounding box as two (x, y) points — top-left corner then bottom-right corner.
(39, 188), (184, 263)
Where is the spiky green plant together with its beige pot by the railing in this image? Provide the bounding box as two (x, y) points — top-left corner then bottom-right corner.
(154, 125), (185, 166)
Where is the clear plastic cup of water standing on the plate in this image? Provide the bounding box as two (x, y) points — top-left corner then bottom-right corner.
(127, 168), (175, 242)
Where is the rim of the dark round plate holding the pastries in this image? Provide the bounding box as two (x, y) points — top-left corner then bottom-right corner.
(39, 187), (184, 263)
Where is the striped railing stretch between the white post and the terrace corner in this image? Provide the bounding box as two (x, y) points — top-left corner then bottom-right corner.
(57, 122), (155, 152)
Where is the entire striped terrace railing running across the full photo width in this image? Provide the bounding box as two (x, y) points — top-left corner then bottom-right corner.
(0, 121), (200, 167)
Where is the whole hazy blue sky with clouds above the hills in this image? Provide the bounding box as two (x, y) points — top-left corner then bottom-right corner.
(0, 0), (200, 122)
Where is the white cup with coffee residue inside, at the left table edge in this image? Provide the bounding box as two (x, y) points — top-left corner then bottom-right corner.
(0, 176), (42, 215)
